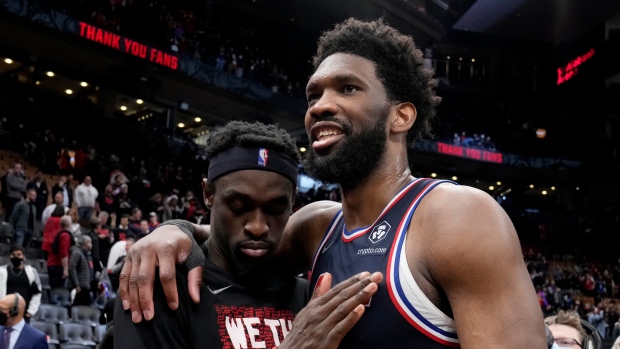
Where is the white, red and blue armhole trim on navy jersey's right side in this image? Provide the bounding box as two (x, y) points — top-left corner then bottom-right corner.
(386, 181), (460, 348)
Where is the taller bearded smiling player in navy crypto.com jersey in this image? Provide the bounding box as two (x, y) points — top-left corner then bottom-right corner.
(120, 19), (546, 349)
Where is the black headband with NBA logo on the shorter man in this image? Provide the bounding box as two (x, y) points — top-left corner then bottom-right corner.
(208, 147), (298, 187)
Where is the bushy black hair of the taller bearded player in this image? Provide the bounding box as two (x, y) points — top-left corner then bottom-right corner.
(312, 18), (441, 142)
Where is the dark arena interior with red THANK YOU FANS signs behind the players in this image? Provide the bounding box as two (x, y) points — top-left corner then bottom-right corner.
(0, 0), (620, 349)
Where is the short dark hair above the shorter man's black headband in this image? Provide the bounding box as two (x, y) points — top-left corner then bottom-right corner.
(206, 121), (301, 191)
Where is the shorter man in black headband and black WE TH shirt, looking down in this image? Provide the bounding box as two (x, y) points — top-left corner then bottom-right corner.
(114, 122), (381, 349)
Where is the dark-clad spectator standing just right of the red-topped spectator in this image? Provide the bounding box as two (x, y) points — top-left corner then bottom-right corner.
(68, 235), (95, 306)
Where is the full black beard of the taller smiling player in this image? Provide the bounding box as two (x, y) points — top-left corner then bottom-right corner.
(304, 108), (389, 191)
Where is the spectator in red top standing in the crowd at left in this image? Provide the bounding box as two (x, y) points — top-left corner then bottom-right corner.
(43, 215), (74, 288)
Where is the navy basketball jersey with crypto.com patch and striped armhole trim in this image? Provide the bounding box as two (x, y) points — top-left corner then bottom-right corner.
(311, 178), (459, 349)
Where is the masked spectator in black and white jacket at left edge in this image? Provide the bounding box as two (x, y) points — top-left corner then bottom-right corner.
(0, 245), (41, 323)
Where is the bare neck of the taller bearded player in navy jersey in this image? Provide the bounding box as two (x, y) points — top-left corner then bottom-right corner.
(342, 148), (413, 231)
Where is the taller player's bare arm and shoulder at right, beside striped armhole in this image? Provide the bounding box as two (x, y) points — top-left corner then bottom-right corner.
(418, 185), (546, 349)
